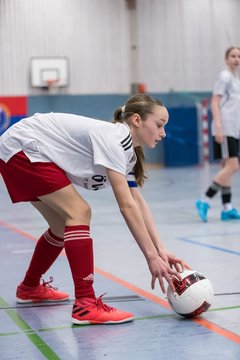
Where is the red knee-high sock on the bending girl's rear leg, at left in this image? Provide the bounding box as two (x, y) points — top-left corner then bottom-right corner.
(22, 229), (64, 287)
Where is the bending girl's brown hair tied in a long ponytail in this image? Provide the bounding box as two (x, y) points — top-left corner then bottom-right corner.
(113, 94), (164, 187)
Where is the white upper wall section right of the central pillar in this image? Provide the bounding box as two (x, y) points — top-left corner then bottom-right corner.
(138, 0), (240, 92)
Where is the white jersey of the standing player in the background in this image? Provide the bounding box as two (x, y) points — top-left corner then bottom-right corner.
(212, 70), (240, 139)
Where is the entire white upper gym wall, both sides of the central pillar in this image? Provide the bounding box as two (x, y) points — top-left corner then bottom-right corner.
(0, 0), (240, 96)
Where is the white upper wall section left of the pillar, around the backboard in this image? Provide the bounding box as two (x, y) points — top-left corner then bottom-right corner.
(0, 0), (129, 96)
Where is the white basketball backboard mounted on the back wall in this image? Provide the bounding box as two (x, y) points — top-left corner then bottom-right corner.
(30, 57), (69, 88)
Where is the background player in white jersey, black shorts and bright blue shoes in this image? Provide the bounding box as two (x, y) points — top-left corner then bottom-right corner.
(196, 47), (240, 222)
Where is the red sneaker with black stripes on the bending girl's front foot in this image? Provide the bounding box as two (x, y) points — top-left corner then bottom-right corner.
(72, 295), (134, 325)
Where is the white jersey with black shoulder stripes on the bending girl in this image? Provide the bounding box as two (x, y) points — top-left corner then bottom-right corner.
(0, 113), (136, 190)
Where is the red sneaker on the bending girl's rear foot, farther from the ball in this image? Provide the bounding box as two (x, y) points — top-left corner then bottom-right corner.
(16, 277), (69, 304)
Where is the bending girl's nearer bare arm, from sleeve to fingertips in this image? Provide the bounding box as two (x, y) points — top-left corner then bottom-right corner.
(107, 169), (181, 293)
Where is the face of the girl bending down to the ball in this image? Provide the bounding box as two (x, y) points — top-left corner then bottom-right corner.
(133, 105), (169, 148)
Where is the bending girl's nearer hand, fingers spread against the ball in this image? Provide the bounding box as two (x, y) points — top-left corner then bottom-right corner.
(148, 256), (182, 294)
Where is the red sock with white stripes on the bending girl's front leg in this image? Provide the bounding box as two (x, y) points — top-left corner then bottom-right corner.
(64, 225), (95, 299)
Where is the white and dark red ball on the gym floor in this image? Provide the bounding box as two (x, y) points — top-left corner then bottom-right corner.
(167, 270), (214, 318)
